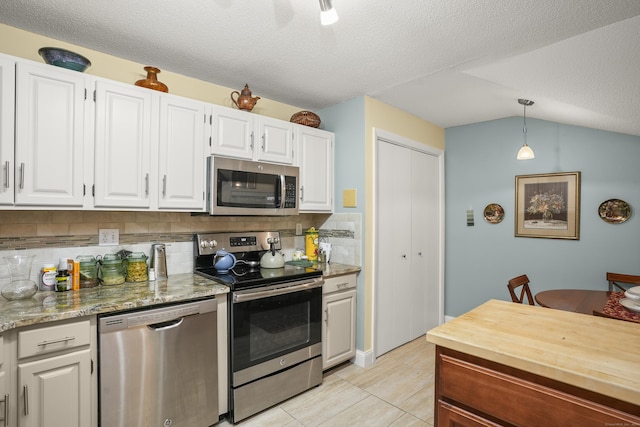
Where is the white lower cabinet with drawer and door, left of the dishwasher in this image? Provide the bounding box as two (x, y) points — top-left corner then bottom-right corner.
(0, 317), (98, 427)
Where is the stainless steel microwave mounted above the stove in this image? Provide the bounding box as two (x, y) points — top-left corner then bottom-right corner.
(207, 156), (300, 216)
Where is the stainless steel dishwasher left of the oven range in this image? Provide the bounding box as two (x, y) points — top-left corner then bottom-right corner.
(98, 299), (218, 427)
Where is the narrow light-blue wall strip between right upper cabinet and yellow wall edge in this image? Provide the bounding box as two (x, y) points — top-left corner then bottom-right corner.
(317, 97), (366, 350)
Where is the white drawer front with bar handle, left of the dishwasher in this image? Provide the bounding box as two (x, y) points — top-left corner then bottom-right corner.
(18, 320), (91, 359)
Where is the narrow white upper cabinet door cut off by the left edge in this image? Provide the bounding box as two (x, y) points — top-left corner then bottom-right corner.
(0, 57), (16, 205)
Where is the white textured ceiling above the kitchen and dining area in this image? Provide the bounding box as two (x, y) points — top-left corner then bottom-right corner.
(0, 0), (640, 135)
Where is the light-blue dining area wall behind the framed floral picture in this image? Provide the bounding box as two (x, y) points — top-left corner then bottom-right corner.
(445, 117), (640, 316)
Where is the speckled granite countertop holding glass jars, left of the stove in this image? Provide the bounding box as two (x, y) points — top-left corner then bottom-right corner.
(0, 273), (229, 332)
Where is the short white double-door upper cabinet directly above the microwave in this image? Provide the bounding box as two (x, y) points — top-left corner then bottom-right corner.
(211, 106), (293, 165)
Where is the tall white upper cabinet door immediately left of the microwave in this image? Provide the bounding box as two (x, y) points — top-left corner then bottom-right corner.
(158, 95), (206, 211)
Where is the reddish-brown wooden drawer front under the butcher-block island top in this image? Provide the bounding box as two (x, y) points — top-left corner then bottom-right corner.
(438, 354), (640, 426)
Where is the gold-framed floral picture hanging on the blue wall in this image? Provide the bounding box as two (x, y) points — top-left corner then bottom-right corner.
(515, 172), (580, 240)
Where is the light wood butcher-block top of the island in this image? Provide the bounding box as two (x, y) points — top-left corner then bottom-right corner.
(427, 300), (640, 405)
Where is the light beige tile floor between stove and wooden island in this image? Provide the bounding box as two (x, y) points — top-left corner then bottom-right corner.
(217, 336), (435, 427)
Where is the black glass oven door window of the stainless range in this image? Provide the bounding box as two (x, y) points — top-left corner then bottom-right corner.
(232, 288), (322, 371)
